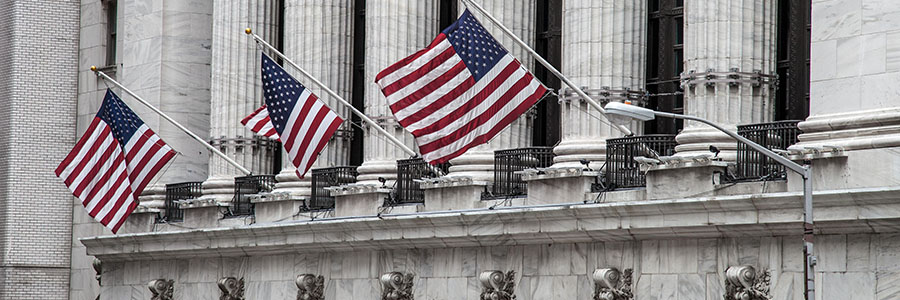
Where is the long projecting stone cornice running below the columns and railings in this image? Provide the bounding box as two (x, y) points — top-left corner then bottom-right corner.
(80, 187), (900, 261)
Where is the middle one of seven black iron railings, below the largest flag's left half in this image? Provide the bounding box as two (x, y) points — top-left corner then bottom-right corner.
(388, 158), (450, 205)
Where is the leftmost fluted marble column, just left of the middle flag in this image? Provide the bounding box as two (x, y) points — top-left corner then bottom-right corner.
(203, 0), (279, 203)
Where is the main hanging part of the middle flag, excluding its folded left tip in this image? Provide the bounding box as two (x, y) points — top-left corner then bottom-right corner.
(262, 54), (344, 178)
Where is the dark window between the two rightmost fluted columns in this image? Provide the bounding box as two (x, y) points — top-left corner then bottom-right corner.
(644, 0), (684, 134)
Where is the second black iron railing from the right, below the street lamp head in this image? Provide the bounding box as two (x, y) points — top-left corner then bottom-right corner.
(592, 134), (677, 191)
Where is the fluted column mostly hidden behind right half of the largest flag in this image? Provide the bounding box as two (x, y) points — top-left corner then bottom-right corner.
(448, 0), (537, 181)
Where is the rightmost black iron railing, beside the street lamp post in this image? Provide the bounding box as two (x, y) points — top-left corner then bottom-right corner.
(735, 121), (801, 180)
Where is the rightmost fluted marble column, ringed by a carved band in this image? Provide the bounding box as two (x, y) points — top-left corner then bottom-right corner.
(675, 0), (777, 160)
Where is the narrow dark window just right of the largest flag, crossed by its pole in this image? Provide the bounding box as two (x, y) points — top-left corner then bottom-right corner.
(532, 0), (562, 146)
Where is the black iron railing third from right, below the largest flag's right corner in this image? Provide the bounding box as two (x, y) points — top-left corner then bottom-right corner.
(489, 147), (553, 197)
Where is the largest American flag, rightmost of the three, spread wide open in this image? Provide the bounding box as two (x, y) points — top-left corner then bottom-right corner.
(375, 10), (547, 164)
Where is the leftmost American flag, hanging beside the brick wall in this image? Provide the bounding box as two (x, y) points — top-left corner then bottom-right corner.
(56, 90), (175, 233)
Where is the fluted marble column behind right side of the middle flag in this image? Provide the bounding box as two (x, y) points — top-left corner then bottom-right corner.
(273, 0), (353, 199)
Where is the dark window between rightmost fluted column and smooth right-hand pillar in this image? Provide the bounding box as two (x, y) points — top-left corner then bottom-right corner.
(775, 0), (810, 120)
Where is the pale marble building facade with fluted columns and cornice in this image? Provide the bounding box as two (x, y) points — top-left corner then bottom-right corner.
(0, 0), (900, 300)
